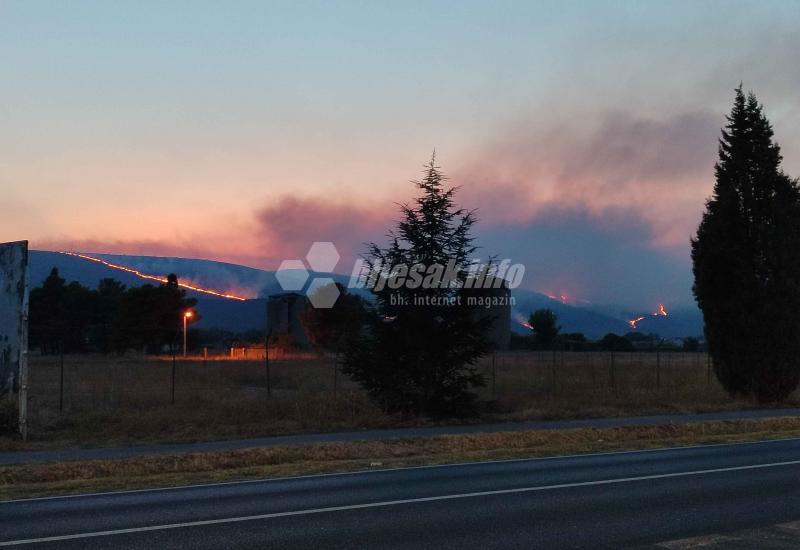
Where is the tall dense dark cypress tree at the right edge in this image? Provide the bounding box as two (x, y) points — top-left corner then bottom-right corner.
(692, 86), (800, 401)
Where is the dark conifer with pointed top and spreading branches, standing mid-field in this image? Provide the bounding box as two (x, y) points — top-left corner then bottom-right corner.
(343, 159), (492, 417)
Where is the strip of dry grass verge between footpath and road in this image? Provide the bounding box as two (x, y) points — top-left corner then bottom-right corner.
(0, 418), (800, 499)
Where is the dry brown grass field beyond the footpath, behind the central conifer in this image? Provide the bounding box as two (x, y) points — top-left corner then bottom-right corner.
(0, 351), (798, 449)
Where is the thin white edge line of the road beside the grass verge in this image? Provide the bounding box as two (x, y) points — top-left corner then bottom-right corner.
(6, 437), (800, 506)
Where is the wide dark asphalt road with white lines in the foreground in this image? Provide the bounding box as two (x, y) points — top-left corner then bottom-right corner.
(0, 439), (800, 550)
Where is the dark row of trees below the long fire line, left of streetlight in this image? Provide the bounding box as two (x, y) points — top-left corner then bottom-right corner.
(29, 268), (197, 354)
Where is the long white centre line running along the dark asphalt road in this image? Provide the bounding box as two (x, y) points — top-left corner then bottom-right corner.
(0, 460), (800, 546)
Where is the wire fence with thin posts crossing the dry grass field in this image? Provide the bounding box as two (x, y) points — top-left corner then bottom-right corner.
(31, 349), (719, 410)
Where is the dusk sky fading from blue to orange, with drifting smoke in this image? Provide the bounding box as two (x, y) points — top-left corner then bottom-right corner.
(0, 0), (800, 310)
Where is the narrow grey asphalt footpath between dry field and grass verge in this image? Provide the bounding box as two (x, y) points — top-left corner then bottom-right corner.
(0, 409), (800, 465)
